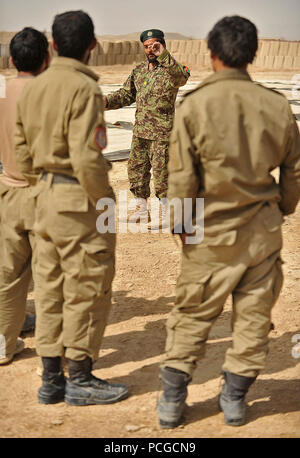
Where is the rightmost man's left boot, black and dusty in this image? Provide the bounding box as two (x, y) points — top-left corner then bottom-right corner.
(157, 367), (192, 429)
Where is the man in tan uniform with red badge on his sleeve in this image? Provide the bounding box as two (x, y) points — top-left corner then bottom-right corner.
(16, 11), (128, 405)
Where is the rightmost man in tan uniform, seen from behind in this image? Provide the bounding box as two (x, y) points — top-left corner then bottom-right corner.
(158, 16), (300, 428)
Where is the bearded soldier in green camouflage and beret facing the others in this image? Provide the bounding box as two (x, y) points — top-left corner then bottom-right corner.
(105, 30), (189, 221)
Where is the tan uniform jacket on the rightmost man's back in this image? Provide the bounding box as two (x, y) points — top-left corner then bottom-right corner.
(168, 69), (300, 234)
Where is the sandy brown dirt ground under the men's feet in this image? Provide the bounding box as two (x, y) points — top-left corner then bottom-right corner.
(0, 70), (300, 439)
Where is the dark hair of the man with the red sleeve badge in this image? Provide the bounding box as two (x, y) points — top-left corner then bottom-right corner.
(52, 10), (95, 60)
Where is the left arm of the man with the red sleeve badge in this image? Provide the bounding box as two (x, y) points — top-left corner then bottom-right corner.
(14, 104), (38, 185)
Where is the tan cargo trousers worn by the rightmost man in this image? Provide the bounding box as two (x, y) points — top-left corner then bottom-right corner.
(162, 204), (283, 377)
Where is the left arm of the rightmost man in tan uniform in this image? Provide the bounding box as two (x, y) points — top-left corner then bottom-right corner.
(167, 103), (201, 232)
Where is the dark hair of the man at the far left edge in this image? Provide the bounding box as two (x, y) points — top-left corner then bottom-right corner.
(9, 27), (49, 72)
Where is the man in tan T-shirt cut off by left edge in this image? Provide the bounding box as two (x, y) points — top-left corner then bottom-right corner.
(0, 27), (49, 364)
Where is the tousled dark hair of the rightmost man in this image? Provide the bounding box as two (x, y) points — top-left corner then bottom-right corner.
(207, 16), (258, 67)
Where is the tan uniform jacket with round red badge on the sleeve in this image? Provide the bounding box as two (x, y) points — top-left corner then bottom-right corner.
(15, 57), (113, 205)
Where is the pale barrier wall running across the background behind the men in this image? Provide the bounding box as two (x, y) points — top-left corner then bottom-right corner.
(0, 38), (300, 70)
